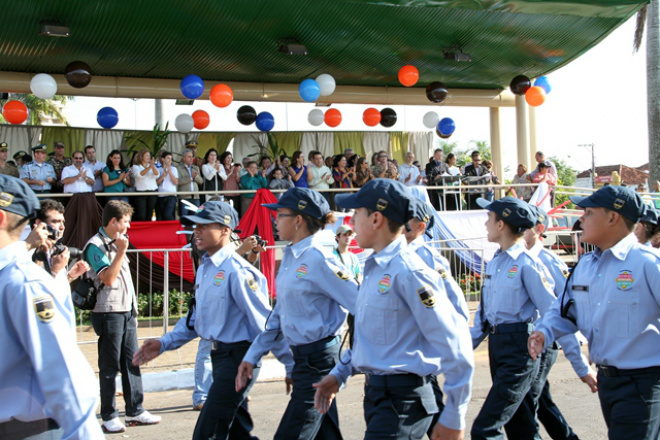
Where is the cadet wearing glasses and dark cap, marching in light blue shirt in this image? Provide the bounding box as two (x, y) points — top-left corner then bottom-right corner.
(236, 188), (357, 440)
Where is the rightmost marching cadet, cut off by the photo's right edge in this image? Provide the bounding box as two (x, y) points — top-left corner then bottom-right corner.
(529, 185), (660, 439)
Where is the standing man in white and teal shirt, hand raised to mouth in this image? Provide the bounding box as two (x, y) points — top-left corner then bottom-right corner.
(84, 200), (160, 433)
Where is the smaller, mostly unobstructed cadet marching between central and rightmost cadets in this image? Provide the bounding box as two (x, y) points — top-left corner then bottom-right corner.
(471, 197), (555, 440)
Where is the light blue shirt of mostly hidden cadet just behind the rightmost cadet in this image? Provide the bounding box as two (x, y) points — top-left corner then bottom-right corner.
(527, 241), (590, 377)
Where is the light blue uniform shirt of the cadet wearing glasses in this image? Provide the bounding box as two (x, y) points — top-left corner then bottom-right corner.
(245, 232), (358, 364)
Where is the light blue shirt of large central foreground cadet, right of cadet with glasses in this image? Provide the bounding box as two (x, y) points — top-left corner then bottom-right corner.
(331, 237), (474, 429)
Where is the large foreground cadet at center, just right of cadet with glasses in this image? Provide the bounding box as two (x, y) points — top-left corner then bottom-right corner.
(314, 179), (474, 440)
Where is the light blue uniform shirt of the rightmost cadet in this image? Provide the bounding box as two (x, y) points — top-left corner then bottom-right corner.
(537, 234), (660, 369)
